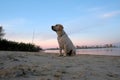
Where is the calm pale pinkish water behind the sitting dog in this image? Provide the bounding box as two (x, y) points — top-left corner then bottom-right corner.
(45, 48), (120, 56)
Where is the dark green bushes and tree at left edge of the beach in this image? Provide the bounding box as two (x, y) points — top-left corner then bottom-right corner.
(0, 26), (42, 52)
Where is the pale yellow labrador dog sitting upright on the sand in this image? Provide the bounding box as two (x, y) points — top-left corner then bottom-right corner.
(51, 24), (76, 56)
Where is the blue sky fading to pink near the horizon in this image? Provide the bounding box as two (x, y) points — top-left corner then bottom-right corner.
(0, 0), (120, 48)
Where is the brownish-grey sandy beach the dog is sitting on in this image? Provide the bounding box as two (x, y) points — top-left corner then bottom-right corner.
(0, 51), (120, 80)
